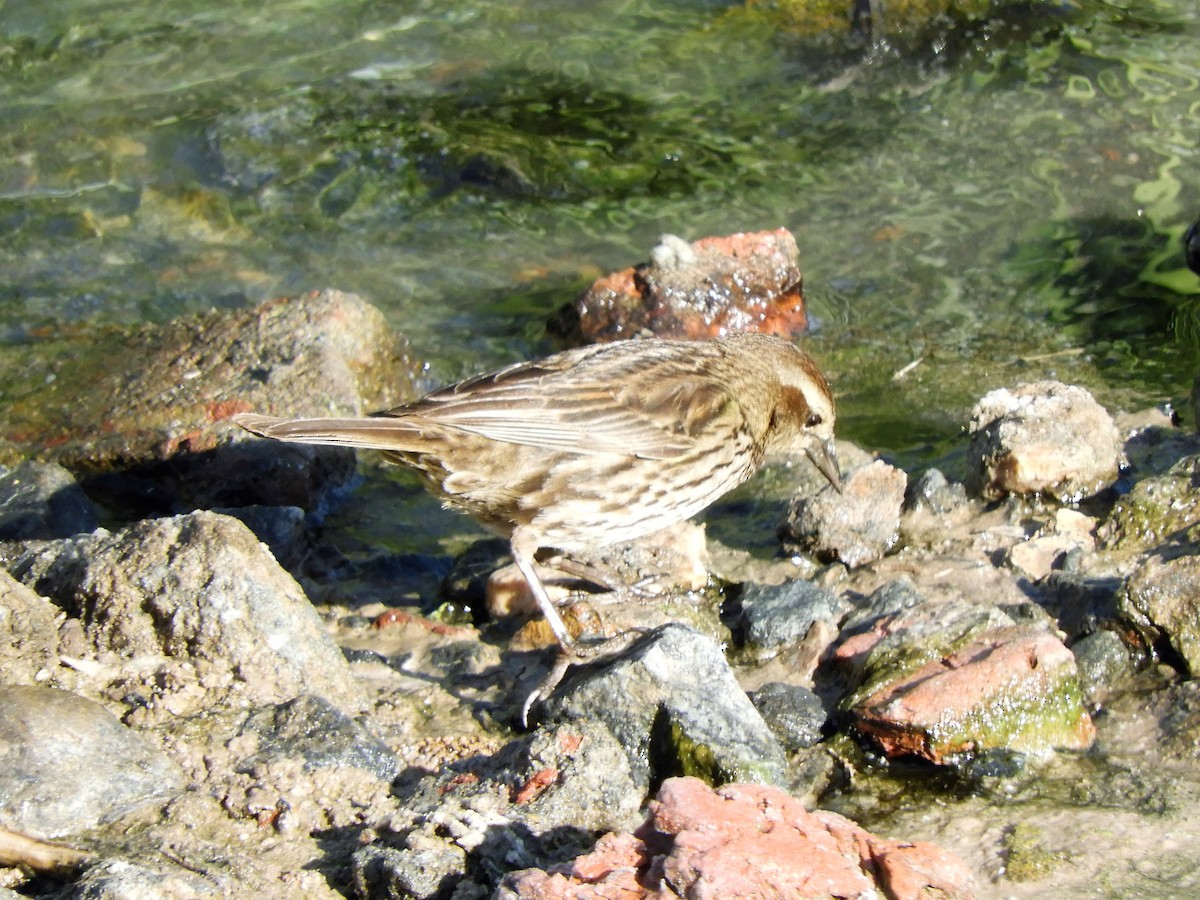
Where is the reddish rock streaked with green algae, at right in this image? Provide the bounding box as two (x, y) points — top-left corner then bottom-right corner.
(834, 581), (1096, 763)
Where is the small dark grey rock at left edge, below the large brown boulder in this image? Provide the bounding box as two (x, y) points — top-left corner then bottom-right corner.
(0, 461), (100, 540)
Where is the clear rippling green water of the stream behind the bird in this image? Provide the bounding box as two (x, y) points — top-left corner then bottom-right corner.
(0, 0), (1200, 466)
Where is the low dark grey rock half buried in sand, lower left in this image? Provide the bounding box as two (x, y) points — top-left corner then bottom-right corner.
(238, 696), (401, 781)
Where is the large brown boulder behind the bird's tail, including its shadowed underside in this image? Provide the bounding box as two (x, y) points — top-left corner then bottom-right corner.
(0, 290), (412, 515)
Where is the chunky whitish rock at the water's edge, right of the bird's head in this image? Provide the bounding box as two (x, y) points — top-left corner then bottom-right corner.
(967, 382), (1122, 503)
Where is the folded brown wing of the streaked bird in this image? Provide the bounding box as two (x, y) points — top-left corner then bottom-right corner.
(379, 342), (736, 458)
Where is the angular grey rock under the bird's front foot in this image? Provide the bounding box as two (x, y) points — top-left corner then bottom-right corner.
(546, 625), (785, 787)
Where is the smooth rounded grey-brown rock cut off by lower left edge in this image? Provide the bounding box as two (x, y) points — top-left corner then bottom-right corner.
(0, 686), (184, 838)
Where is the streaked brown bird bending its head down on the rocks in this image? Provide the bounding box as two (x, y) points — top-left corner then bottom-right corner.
(233, 334), (841, 650)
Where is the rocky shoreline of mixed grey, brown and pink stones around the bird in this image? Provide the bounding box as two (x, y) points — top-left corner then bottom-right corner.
(0, 292), (1200, 900)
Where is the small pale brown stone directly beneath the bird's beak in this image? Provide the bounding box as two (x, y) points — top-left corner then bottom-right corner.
(784, 460), (907, 569)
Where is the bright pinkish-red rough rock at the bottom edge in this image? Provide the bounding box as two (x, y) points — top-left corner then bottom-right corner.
(494, 778), (974, 900)
